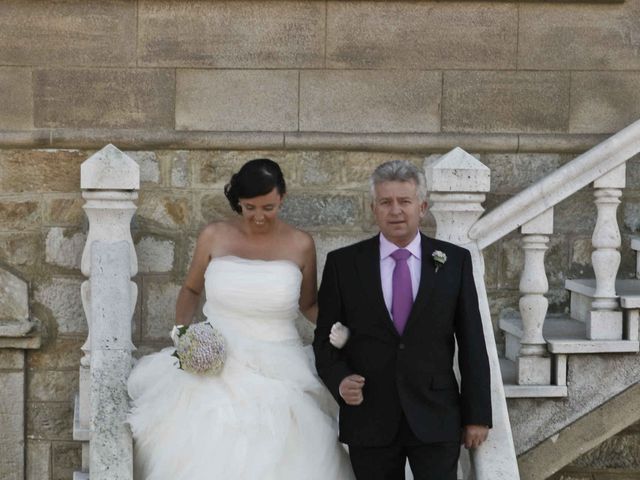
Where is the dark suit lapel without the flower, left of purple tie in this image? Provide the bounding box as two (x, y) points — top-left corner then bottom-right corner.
(356, 235), (398, 336)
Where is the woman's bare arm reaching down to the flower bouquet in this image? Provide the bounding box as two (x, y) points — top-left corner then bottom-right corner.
(176, 224), (216, 325)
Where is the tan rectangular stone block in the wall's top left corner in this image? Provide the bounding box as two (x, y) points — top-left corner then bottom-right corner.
(0, 0), (136, 66)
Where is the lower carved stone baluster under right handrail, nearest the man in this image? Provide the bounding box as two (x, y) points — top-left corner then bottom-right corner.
(516, 208), (553, 385)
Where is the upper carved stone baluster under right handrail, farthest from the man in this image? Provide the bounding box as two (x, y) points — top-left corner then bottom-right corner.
(587, 164), (626, 340)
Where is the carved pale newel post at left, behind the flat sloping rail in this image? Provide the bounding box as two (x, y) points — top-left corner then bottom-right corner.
(73, 145), (140, 478)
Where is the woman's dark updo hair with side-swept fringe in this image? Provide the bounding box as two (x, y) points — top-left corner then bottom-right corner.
(224, 158), (287, 213)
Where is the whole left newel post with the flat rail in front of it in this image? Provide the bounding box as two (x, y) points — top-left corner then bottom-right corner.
(74, 145), (140, 480)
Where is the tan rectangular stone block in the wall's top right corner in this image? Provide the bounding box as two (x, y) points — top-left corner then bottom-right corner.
(518, 1), (640, 70)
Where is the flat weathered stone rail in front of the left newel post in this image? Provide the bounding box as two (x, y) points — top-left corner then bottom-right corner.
(89, 241), (137, 480)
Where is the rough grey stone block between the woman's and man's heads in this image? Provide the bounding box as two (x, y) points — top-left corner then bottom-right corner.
(281, 193), (362, 228)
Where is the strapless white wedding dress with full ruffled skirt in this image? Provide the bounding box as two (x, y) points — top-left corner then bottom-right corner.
(128, 256), (353, 480)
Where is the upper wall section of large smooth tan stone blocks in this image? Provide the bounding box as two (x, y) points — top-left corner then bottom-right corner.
(0, 0), (640, 150)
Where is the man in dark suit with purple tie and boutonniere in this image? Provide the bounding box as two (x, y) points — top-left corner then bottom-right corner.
(313, 160), (491, 480)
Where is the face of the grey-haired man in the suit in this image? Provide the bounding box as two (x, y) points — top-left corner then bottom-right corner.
(371, 181), (427, 247)
